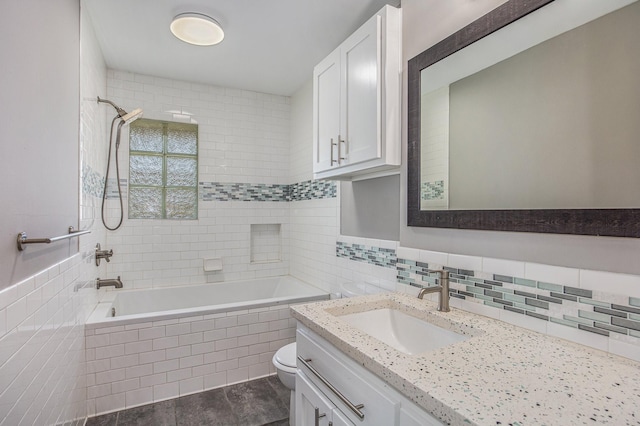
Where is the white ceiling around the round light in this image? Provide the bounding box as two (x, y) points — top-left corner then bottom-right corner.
(82, 0), (400, 96)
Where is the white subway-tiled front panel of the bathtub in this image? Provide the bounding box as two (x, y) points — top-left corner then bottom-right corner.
(85, 305), (295, 416)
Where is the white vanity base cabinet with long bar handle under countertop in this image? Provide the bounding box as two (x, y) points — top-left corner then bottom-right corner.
(295, 323), (442, 426)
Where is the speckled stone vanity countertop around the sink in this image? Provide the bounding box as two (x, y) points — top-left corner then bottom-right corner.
(291, 293), (640, 426)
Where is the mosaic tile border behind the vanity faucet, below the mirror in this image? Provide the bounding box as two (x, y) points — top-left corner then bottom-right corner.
(396, 259), (640, 343)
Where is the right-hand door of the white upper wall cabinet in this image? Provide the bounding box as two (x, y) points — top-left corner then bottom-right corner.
(340, 15), (382, 165)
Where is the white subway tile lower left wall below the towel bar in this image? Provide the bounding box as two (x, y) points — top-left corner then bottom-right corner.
(0, 254), (95, 425)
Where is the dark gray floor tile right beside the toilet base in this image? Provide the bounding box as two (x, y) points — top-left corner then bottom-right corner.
(224, 378), (289, 426)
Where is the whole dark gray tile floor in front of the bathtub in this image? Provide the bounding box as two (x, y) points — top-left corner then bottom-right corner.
(86, 376), (289, 426)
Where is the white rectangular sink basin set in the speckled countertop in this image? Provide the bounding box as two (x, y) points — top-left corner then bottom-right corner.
(339, 308), (469, 355)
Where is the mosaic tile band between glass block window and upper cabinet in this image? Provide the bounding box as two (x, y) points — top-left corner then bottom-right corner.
(198, 180), (337, 202)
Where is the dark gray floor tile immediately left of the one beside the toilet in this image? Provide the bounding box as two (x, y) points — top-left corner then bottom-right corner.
(176, 388), (240, 426)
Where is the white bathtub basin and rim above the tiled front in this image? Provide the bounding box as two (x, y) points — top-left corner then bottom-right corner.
(87, 276), (329, 325)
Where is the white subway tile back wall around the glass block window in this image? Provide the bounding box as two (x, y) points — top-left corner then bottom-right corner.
(107, 70), (290, 288)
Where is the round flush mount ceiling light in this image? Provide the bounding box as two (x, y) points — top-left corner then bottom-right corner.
(170, 12), (224, 46)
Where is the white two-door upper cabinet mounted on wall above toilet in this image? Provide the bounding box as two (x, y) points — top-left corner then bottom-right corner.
(313, 6), (402, 179)
